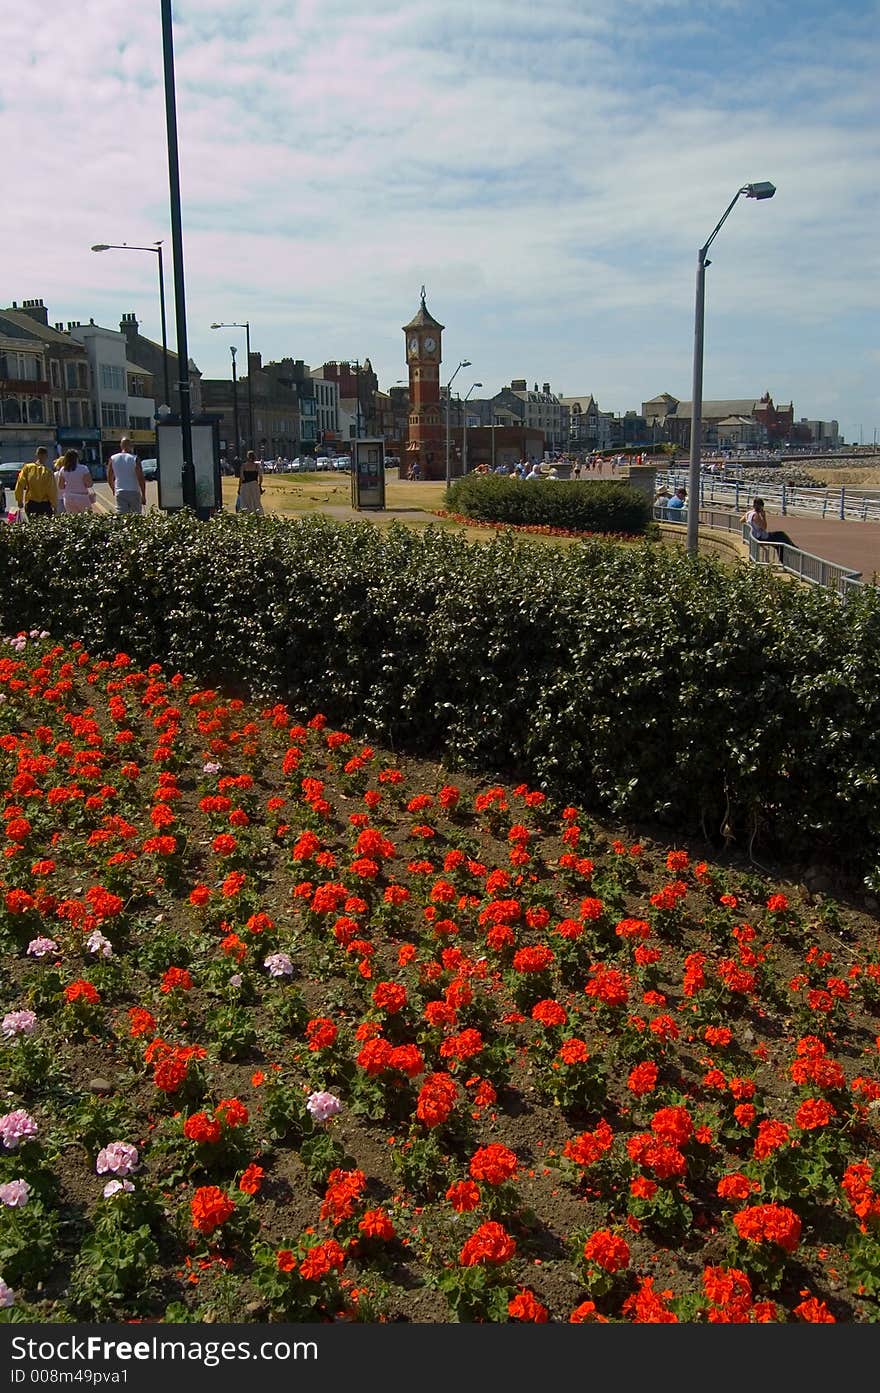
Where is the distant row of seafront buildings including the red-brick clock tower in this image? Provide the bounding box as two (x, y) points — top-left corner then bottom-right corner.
(0, 298), (840, 478)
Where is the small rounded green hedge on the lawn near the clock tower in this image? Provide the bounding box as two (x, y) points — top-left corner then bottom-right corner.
(446, 474), (652, 536)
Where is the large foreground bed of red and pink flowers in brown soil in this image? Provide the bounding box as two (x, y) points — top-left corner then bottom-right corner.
(0, 635), (880, 1323)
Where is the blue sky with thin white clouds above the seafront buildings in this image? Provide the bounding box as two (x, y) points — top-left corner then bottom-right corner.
(0, 0), (880, 442)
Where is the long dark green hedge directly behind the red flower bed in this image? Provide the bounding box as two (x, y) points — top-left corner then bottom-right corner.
(0, 512), (880, 868)
